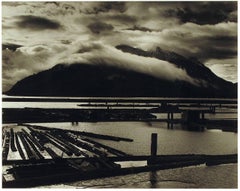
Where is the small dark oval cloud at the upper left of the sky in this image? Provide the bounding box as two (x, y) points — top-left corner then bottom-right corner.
(16, 15), (61, 30)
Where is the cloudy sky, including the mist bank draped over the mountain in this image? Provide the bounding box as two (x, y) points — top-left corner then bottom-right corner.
(2, 1), (237, 91)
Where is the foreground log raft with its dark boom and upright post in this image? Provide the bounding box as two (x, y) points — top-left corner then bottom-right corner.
(3, 126), (237, 188)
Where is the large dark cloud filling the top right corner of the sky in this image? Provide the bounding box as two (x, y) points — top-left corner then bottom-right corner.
(165, 2), (237, 25)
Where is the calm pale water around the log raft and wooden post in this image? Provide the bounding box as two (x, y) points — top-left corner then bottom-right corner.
(3, 97), (238, 188)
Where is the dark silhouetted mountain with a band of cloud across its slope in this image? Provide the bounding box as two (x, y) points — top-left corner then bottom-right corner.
(7, 45), (237, 97)
